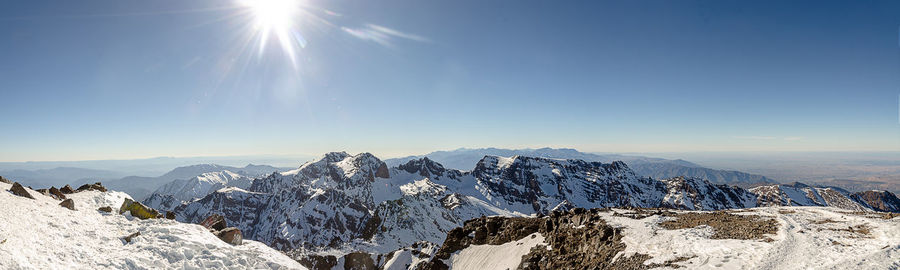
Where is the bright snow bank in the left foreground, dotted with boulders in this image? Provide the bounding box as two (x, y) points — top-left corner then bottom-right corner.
(0, 183), (303, 269)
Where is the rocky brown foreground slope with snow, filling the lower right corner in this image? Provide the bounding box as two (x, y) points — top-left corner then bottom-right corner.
(418, 207), (900, 269)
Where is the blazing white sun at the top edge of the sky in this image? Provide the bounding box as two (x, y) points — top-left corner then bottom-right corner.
(240, 0), (303, 62)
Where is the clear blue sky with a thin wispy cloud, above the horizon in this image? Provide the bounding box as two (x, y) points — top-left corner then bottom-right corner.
(0, 0), (900, 161)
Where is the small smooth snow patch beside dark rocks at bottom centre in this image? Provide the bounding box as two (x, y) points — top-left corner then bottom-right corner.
(449, 233), (544, 270)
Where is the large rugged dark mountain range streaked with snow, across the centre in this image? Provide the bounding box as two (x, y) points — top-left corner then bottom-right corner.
(169, 152), (816, 268)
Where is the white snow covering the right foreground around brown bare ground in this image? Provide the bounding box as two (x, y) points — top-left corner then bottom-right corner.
(601, 207), (900, 270)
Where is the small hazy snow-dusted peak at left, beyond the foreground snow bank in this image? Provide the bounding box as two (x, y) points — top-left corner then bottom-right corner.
(144, 170), (253, 210)
